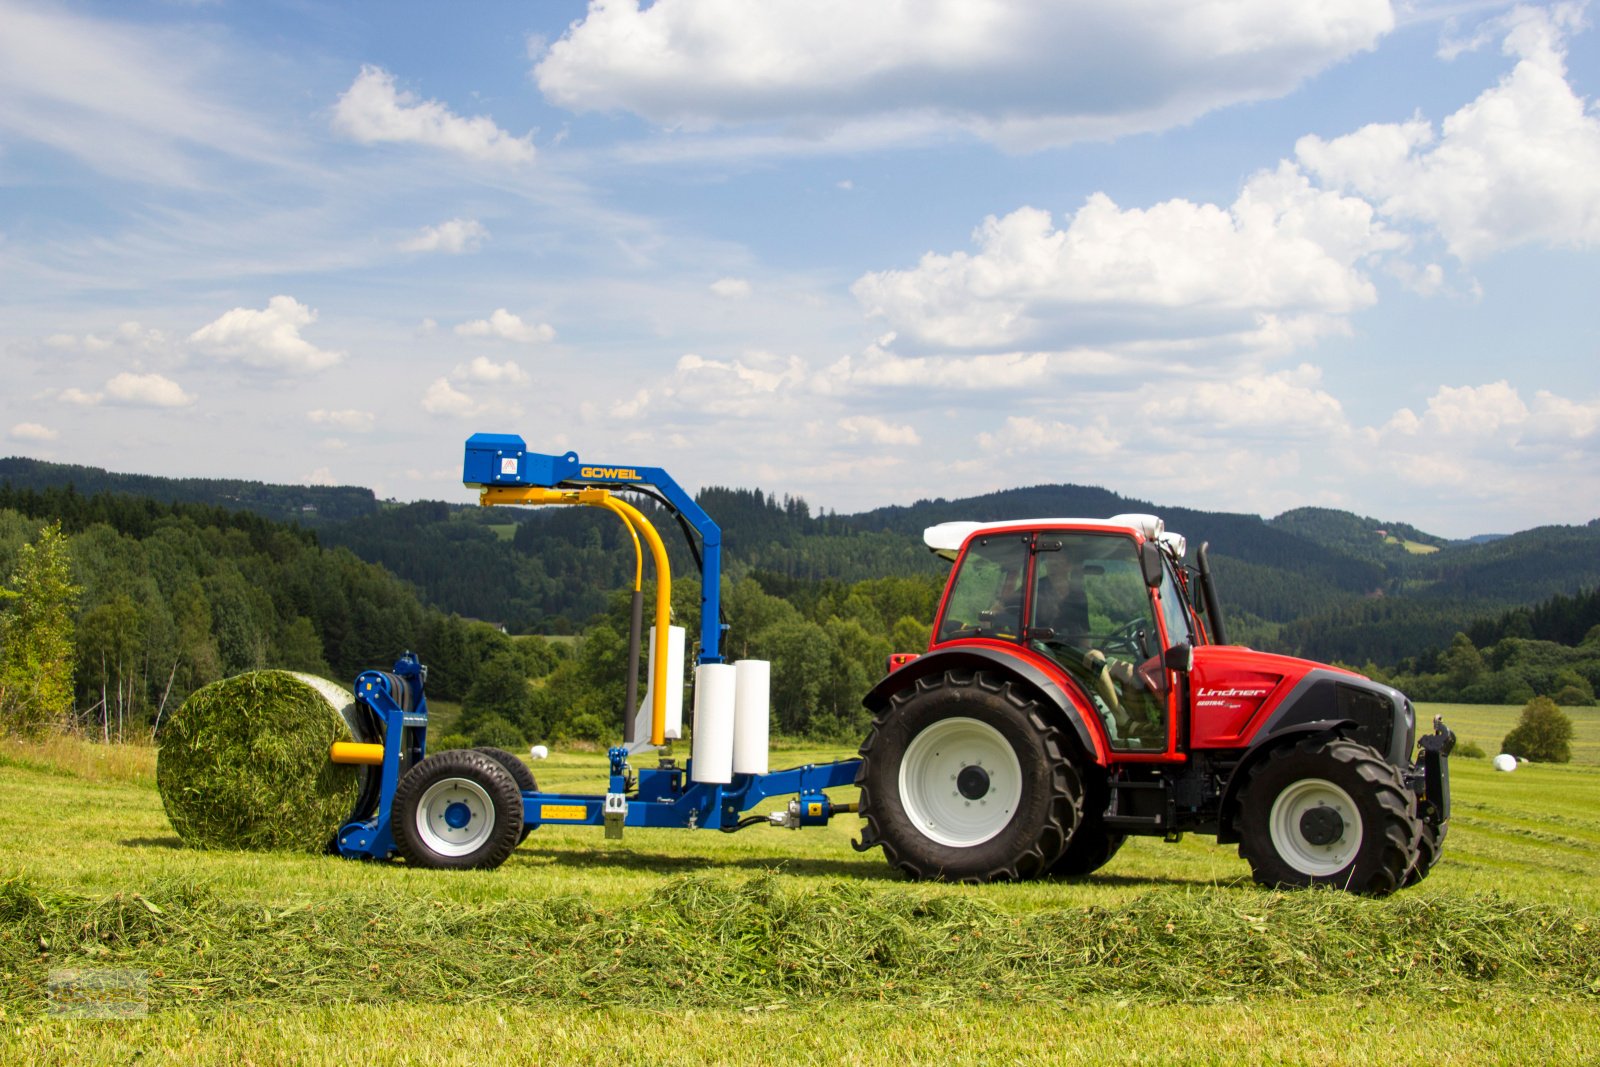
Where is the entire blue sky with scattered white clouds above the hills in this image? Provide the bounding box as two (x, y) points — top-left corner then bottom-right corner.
(0, 0), (1600, 536)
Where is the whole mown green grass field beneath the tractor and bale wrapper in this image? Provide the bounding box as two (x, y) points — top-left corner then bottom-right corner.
(0, 705), (1600, 1064)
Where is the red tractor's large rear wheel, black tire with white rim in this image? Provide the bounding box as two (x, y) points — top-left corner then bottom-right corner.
(856, 670), (1083, 881)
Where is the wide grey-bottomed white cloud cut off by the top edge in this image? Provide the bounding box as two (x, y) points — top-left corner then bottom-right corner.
(531, 0), (1394, 146)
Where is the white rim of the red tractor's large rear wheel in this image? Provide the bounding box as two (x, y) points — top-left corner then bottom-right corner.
(899, 718), (1022, 848)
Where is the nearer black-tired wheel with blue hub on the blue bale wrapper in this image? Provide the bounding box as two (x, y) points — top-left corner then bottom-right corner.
(390, 749), (523, 870)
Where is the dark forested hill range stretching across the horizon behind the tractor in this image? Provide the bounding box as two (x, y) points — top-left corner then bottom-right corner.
(0, 461), (1600, 664)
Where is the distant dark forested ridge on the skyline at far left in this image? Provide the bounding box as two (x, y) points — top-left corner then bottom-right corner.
(0, 456), (378, 526)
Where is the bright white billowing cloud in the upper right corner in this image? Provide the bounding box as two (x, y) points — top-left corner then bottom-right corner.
(1296, 5), (1600, 259)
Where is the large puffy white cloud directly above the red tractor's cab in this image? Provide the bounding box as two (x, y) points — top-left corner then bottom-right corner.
(851, 163), (1403, 347)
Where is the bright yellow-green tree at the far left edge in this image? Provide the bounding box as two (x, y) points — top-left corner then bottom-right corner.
(0, 522), (80, 737)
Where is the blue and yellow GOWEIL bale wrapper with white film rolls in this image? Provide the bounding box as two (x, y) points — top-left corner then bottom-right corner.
(331, 434), (861, 869)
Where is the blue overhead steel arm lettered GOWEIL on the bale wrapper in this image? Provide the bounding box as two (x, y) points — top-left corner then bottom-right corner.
(461, 434), (723, 664)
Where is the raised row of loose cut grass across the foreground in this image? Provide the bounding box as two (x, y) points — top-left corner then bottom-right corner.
(0, 873), (1600, 1013)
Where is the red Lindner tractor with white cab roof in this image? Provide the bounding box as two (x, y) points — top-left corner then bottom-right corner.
(856, 515), (1454, 894)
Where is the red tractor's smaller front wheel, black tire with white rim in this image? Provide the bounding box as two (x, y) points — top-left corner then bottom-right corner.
(1238, 734), (1422, 896)
